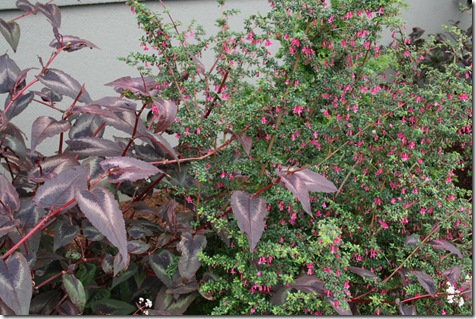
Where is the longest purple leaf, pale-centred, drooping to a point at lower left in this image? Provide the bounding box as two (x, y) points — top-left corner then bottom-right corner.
(75, 187), (129, 276)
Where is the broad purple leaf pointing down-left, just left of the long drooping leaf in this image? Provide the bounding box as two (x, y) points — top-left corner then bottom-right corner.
(33, 166), (88, 210)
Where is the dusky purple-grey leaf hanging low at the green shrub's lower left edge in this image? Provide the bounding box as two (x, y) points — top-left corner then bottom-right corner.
(177, 233), (207, 280)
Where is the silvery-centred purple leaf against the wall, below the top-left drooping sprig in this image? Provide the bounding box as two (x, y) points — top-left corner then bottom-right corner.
(37, 69), (92, 103)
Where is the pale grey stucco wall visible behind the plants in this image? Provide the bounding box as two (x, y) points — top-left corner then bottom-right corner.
(0, 0), (471, 155)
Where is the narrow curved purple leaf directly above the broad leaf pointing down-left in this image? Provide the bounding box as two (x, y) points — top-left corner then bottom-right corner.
(28, 153), (79, 183)
